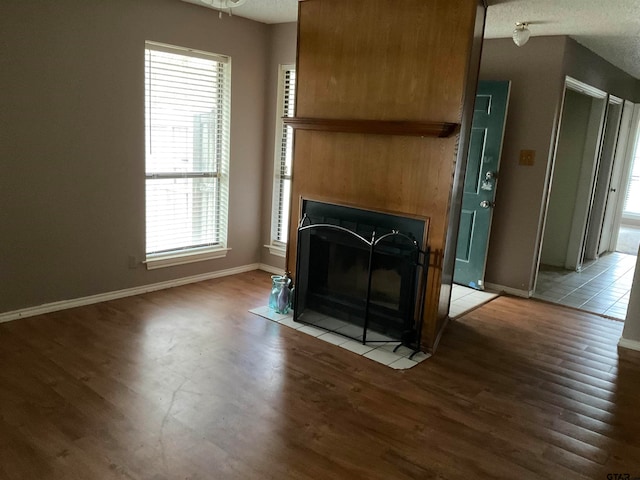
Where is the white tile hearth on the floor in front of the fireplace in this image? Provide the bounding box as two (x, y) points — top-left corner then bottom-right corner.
(249, 306), (430, 370)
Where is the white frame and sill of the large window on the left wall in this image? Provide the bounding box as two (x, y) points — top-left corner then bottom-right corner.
(143, 40), (231, 270)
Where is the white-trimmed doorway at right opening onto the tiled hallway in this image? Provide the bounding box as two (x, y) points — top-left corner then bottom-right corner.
(534, 79), (637, 319)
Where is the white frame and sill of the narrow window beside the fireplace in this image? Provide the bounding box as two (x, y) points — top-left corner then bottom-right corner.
(265, 63), (296, 257)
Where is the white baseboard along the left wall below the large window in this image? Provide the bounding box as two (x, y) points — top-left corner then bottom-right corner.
(0, 263), (262, 323)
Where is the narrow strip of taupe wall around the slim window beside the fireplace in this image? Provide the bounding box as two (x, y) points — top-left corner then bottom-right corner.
(260, 23), (298, 270)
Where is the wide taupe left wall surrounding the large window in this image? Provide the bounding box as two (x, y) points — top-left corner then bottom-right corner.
(0, 0), (270, 312)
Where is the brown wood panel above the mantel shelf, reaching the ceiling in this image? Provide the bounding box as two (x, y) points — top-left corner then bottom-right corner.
(296, 0), (475, 123)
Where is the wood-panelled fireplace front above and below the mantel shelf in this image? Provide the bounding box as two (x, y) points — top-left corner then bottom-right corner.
(287, 0), (488, 350)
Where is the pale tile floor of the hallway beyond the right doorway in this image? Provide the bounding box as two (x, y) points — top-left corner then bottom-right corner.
(533, 252), (636, 320)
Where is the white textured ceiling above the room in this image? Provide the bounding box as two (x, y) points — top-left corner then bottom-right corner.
(184, 0), (640, 79)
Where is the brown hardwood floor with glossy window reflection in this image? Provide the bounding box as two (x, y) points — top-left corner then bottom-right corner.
(0, 272), (640, 480)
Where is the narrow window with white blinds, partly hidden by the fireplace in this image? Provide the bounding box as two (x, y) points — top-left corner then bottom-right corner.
(269, 65), (296, 256)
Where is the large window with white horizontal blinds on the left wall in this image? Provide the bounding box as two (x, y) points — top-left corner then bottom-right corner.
(145, 42), (231, 268)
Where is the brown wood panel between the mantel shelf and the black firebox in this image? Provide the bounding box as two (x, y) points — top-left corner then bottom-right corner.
(288, 131), (456, 271)
